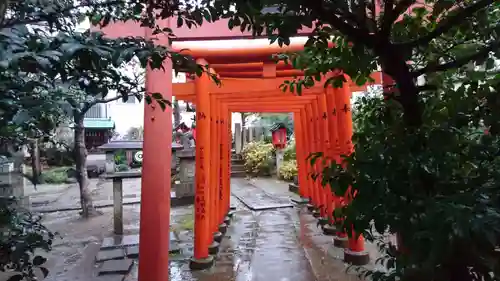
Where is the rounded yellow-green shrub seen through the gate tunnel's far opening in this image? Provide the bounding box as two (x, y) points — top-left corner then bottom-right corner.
(241, 142), (274, 176)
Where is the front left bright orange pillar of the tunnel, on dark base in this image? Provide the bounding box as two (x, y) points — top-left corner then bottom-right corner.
(189, 60), (213, 270)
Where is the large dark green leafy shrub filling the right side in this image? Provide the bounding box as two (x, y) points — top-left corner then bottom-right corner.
(323, 89), (500, 281)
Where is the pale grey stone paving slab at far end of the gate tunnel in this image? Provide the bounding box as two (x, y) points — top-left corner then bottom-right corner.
(231, 179), (293, 211)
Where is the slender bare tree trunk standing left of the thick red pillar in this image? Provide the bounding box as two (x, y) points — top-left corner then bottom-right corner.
(74, 113), (99, 218)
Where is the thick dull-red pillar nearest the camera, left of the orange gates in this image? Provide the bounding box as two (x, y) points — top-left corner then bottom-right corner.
(138, 61), (172, 281)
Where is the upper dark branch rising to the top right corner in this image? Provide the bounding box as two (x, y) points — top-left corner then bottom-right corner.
(395, 0), (495, 48)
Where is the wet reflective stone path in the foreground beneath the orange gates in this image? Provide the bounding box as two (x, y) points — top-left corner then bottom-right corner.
(126, 209), (317, 281)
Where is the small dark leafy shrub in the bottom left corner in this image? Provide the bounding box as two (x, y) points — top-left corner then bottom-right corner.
(0, 198), (55, 281)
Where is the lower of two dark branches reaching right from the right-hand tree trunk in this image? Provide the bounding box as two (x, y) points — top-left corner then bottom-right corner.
(412, 41), (500, 77)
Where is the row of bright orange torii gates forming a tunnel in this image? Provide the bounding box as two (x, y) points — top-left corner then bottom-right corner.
(168, 42), (381, 268)
